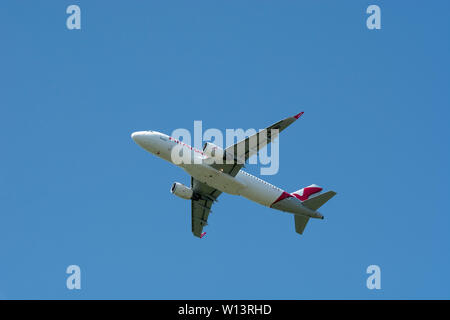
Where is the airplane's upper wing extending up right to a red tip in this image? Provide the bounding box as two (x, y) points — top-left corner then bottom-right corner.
(212, 112), (303, 177)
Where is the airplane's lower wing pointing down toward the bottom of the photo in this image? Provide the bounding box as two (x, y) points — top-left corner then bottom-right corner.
(191, 177), (222, 238)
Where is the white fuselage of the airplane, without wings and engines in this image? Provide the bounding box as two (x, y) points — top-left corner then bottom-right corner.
(132, 131), (322, 215)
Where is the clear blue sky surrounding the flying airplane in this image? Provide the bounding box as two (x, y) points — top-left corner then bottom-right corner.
(0, 0), (450, 299)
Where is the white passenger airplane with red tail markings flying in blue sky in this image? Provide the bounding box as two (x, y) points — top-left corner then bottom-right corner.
(131, 112), (336, 238)
